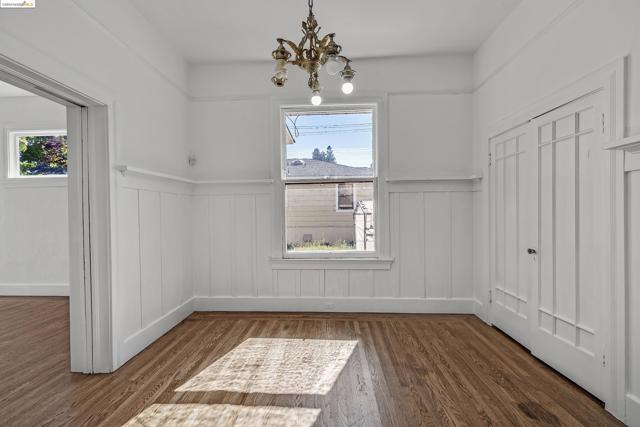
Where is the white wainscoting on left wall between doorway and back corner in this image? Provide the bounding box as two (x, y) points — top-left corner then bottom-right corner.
(116, 176), (194, 365)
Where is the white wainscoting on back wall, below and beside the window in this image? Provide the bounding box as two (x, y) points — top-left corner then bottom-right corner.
(192, 184), (473, 312)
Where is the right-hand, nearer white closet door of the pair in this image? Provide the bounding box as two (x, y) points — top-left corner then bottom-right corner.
(530, 93), (610, 397)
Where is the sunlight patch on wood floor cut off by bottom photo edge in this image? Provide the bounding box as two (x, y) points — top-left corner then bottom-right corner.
(123, 403), (320, 427)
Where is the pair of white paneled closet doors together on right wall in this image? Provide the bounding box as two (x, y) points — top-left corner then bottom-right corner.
(490, 92), (611, 398)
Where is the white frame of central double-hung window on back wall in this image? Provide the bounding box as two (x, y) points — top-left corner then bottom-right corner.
(278, 102), (381, 260)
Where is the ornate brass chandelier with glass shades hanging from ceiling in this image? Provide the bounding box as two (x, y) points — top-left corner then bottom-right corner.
(271, 0), (356, 105)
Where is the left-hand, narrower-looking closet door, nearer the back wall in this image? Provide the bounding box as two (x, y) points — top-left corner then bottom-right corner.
(490, 123), (535, 347)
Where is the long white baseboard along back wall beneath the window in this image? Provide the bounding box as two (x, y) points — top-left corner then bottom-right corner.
(193, 296), (474, 314)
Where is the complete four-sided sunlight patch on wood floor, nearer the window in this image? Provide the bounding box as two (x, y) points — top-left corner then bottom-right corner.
(176, 338), (358, 395)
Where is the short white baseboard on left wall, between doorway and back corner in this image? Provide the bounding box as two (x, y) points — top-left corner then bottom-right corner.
(120, 298), (193, 369)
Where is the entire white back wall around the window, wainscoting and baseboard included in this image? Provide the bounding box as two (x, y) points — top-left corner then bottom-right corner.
(189, 56), (474, 312)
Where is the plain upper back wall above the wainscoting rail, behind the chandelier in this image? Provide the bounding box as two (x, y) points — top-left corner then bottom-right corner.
(189, 56), (472, 180)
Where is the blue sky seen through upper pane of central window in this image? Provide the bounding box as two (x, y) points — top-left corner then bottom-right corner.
(286, 112), (373, 167)
